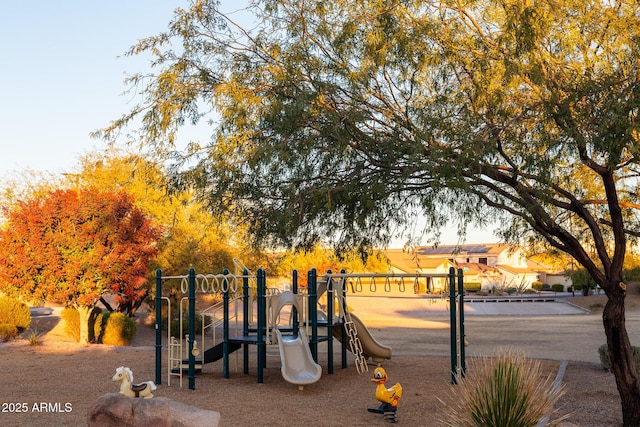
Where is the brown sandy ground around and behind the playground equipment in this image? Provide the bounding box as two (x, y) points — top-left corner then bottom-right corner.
(0, 297), (640, 427)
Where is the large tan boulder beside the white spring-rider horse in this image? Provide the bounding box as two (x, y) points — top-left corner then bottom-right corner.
(87, 393), (220, 427)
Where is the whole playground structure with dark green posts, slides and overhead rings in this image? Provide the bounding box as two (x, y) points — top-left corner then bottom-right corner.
(155, 260), (465, 389)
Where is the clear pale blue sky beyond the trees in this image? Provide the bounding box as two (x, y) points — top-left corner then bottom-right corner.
(0, 0), (495, 247)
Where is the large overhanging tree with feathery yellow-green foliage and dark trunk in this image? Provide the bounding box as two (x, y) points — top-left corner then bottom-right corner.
(105, 0), (640, 425)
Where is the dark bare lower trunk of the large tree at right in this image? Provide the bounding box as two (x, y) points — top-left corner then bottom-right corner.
(602, 283), (640, 427)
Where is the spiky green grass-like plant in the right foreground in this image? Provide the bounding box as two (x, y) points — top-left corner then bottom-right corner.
(438, 350), (563, 427)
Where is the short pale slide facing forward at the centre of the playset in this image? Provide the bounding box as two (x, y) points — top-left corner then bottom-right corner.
(275, 329), (322, 390)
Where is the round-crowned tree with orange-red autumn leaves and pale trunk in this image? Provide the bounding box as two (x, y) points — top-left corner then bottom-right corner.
(0, 188), (160, 343)
